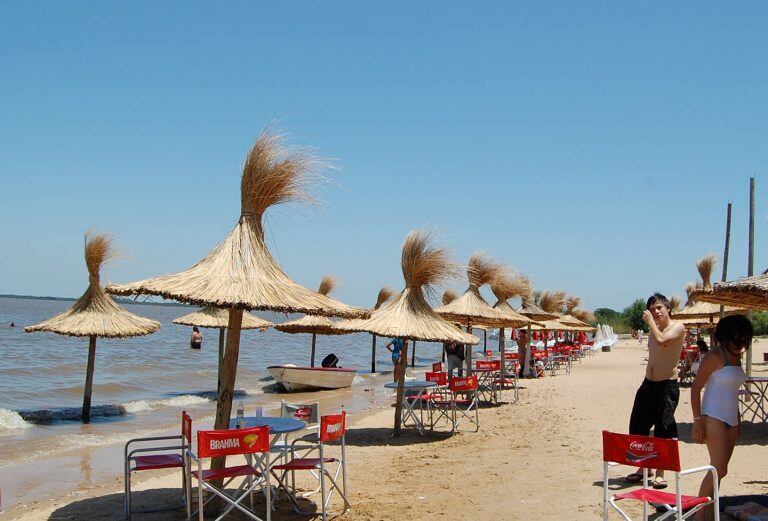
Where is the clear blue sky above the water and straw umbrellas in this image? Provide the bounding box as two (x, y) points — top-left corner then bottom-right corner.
(0, 1), (768, 309)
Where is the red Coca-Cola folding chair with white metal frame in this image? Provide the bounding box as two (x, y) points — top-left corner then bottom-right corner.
(603, 431), (720, 521)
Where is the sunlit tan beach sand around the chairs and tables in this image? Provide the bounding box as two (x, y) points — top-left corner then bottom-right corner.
(6, 339), (768, 521)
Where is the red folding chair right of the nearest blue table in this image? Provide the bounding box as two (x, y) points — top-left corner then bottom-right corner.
(272, 411), (349, 521)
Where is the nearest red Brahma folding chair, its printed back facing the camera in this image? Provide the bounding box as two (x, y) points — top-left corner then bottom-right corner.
(187, 426), (272, 521)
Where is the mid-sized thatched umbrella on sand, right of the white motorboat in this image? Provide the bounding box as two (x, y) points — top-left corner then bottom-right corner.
(336, 230), (480, 436)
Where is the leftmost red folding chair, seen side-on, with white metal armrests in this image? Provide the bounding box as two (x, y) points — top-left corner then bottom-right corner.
(123, 411), (192, 519)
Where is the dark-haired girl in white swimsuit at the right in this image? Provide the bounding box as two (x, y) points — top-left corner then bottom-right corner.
(691, 315), (754, 520)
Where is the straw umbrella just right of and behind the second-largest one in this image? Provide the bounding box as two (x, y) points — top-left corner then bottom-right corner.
(435, 252), (528, 374)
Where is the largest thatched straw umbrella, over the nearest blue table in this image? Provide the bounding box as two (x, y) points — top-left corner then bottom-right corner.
(107, 130), (367, 450)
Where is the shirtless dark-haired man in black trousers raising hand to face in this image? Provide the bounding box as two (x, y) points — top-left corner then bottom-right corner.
(626, 293), (685, 489)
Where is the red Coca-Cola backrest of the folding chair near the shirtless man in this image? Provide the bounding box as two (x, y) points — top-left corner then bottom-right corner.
(603, 431), (680, 472)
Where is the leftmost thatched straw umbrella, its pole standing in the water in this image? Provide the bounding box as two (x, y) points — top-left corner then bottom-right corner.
(24, 232), (160, 422)
